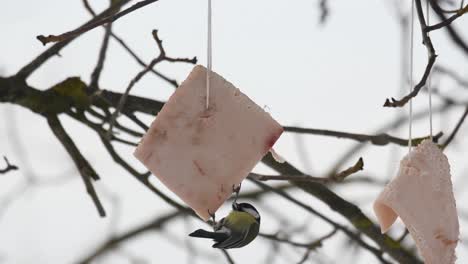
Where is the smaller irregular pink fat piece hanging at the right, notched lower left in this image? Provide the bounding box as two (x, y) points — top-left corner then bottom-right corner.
(374, 140), (459, 264)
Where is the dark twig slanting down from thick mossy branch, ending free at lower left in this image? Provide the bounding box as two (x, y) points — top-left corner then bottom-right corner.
(47, 116), (106, 217)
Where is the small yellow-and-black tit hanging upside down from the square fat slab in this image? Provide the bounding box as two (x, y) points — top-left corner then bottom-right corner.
(189, 186), (260, 249)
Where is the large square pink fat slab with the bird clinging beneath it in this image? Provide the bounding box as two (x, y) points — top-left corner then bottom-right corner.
(134, 66), (283, 220)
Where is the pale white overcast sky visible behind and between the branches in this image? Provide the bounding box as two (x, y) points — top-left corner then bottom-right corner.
(0, 0), (468, 263)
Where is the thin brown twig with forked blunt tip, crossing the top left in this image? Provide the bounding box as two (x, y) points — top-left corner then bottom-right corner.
(36, 0), (158, 45)
